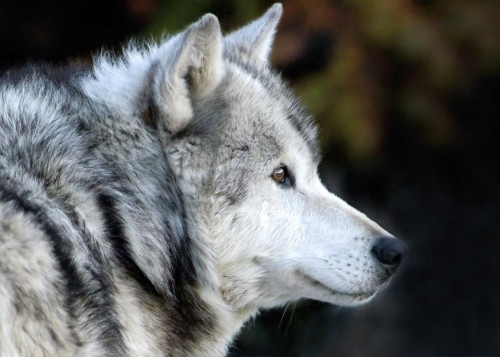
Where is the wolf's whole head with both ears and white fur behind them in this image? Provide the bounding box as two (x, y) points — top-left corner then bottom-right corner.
(82, 4), (405, 318)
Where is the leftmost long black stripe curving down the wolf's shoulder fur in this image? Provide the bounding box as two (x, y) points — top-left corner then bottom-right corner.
(0, 186), (125, 356)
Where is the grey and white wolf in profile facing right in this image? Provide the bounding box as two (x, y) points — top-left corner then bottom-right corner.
(0, 4), (406, 356)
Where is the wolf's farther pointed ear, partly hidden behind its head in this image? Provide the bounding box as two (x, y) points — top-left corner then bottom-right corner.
(224, 3), (283, 62)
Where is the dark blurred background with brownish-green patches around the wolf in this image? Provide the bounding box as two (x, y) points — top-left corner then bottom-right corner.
(0, 0), (500, 357)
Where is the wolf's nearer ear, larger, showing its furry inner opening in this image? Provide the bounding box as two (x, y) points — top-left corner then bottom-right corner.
(152, 14), (224, 134)
